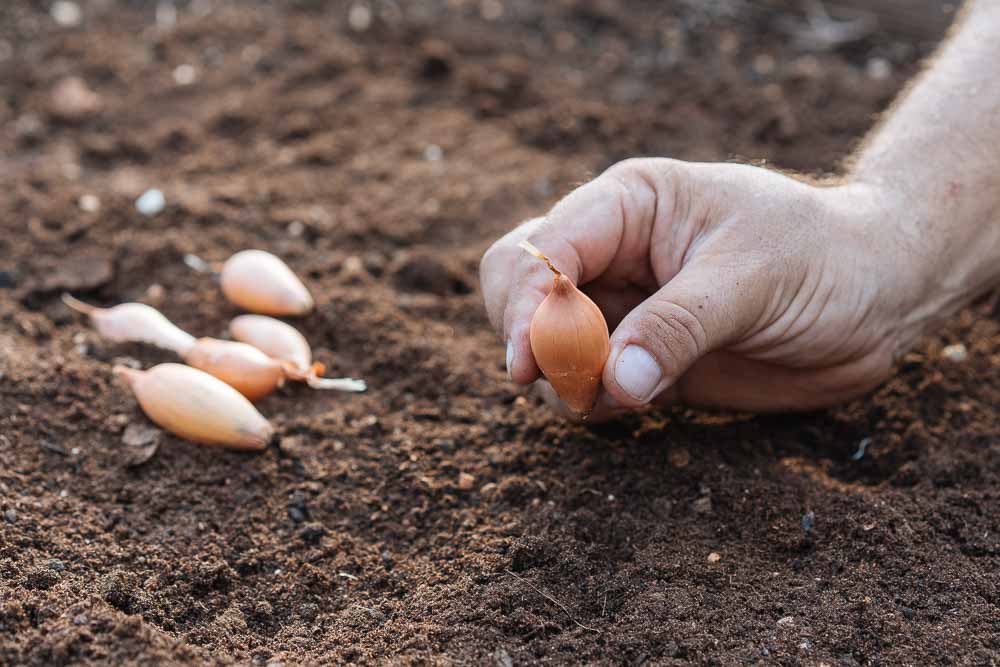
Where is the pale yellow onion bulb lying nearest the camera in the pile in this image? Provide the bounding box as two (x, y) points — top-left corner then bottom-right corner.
(114, 364), (274, 450)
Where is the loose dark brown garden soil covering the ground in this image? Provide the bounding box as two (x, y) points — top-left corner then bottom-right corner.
(0, 0), (1000, 665)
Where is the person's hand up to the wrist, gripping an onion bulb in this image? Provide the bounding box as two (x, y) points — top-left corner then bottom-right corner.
(480, 159), (926, 419)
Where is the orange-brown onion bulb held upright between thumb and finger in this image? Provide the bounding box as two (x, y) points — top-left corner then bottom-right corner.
(518, 241), (611, 417)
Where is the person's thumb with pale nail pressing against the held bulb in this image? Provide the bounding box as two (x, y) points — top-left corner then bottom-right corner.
(603, 261), (765, 407)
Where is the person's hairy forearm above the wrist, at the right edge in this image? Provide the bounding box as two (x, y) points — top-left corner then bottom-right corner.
(851, 0), (1000, 338)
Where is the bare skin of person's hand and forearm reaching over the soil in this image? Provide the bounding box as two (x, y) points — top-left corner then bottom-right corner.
(480, 0), (1000, 419)
